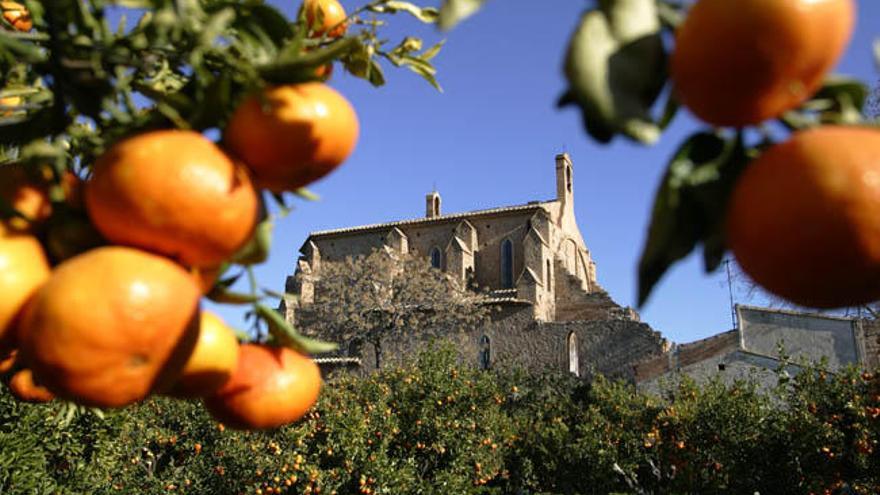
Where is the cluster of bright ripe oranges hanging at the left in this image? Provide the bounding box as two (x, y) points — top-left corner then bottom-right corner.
(0, 0), (358, 428)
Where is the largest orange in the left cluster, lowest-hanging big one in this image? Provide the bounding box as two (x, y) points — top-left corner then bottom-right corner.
(19, 246), (200, 407)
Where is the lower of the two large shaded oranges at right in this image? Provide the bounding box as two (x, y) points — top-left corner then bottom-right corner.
(727, 126), (880, 308)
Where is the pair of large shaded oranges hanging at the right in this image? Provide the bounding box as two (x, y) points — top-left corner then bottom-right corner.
(670, 0), (880, 308)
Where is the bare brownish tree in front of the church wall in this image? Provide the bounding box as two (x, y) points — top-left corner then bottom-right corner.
(296, 250), (489, 368)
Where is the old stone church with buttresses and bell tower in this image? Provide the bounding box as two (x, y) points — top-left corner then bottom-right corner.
(282, 153), (667, 379)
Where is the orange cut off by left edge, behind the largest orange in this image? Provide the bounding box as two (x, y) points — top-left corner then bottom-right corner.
(0, 223), (51, 349)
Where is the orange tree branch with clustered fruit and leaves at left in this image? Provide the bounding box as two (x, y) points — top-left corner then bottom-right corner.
(0, 0), (440, 428)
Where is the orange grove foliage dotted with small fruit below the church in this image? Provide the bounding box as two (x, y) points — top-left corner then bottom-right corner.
(0, 348), (880, 494)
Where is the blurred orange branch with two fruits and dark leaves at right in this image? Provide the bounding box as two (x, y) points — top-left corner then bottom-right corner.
(440, 0), (880, 308)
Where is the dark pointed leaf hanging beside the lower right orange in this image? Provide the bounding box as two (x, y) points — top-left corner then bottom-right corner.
(638, 132), (747, 305)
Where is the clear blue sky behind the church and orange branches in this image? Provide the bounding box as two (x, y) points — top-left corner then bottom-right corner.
(211, 0), (880, 342)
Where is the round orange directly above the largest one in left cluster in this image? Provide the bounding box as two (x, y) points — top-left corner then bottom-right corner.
(85, 130), (258, 267)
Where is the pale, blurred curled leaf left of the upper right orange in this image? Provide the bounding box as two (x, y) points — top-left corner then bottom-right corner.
(559, 0), (666, 143)
